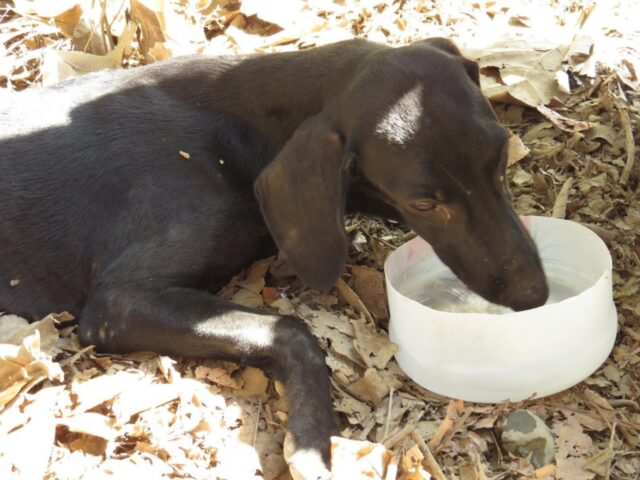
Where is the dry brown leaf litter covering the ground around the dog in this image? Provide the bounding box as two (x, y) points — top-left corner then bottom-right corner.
(0, 0), (640, 480)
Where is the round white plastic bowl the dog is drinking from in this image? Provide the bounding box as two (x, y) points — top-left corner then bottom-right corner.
(385, 217), (617, 402)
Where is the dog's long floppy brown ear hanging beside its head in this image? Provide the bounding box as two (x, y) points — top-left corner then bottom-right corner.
(254, 114), (351, 290)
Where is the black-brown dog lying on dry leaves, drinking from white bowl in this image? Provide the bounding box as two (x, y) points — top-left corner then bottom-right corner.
(0, 39), (547, 476)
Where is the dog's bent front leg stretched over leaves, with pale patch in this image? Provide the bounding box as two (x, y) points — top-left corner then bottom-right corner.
(80, 284), (336, 480)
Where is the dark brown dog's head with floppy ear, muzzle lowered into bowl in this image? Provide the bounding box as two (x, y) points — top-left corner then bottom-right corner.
(255, 39), (548, 310)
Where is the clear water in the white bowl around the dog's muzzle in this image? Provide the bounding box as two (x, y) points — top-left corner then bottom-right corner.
(397, 261), (590, 315)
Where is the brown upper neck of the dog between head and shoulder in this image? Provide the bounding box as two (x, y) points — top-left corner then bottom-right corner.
(166, 41), (387, 147)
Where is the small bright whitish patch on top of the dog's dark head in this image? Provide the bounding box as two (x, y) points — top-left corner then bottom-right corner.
(374, 85), (423, 145)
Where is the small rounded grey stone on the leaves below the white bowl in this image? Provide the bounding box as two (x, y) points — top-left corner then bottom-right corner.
(501, 410), (555, 468)
